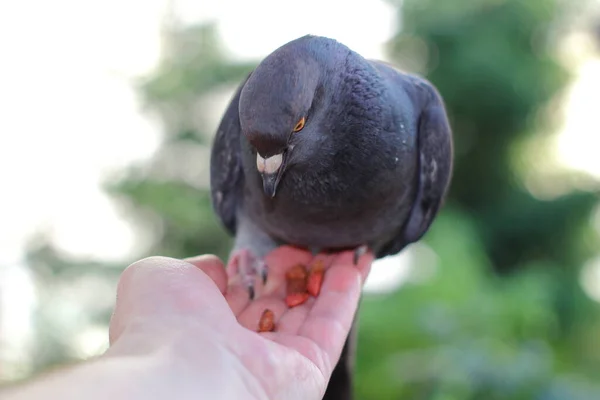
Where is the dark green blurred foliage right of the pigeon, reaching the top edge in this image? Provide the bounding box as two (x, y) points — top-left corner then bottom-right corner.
(390, 0), (596, 270)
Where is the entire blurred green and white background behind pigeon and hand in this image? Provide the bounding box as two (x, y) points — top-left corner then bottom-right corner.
(0, 0), (600, 400)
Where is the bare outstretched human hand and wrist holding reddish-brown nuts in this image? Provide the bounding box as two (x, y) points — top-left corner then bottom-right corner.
(0, 247), (373, 400)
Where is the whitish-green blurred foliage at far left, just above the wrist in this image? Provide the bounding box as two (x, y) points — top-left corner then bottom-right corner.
(21, 235), (123, 373)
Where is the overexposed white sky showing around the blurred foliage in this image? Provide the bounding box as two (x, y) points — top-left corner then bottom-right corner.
(0, 0), (600, 378)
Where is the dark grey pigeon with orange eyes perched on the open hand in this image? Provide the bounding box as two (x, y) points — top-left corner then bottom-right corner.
(210, 35), (453, 400)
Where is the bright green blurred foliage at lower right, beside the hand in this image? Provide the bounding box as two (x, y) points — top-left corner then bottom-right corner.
(356, 211), (600, 400)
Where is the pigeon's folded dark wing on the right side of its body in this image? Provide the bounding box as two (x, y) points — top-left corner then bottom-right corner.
(377, 75), (453, 258)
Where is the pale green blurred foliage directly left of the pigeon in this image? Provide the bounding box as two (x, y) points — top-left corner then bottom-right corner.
(107, 21), (254, 258)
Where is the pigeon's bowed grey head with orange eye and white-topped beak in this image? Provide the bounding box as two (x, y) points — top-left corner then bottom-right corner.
(239, 37), (338, 197)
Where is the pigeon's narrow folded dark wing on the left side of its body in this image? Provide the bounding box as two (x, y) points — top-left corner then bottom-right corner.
(210, 75), (250, 235)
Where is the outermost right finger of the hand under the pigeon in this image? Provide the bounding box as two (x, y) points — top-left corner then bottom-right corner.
(298, 255), (373, 376)
